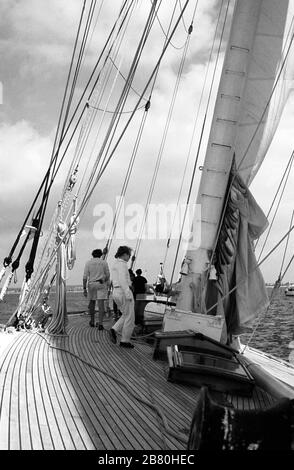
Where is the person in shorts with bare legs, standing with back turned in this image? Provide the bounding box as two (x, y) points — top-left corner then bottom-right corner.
(83, 249), (110, 330)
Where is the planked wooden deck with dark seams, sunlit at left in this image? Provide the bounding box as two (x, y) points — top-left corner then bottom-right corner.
(0, 315), (271, 450)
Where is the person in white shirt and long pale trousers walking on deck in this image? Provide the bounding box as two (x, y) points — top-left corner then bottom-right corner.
(109, 246), (135, 348)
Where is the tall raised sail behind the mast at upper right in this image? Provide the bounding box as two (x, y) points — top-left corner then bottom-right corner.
(235, 0), (293, 185)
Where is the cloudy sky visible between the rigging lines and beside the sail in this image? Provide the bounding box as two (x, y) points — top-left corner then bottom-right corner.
(0, 0), (294, 290)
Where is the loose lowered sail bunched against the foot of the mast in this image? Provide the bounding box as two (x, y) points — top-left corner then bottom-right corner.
(212, 167), (268, 335)
